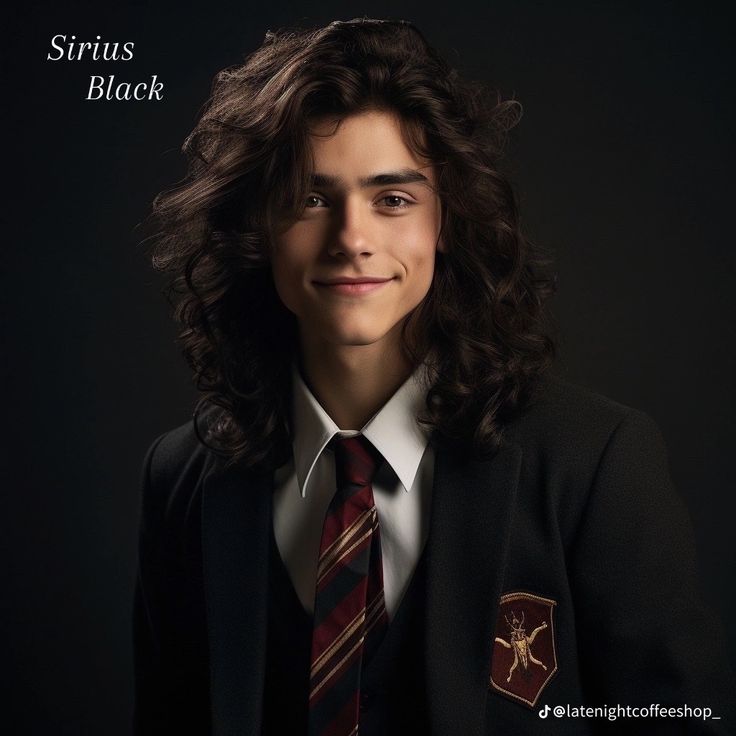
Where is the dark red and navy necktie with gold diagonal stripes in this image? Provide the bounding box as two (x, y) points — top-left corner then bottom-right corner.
(309, 435), (388, 736)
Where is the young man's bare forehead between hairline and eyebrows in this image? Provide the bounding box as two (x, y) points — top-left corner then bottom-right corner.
(309, 110), (432, 183)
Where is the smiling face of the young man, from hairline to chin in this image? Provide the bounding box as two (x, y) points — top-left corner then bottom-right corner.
(272, 111), (441, 356)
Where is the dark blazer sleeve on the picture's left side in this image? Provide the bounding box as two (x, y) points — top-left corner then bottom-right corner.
(133, 435), (209, 736)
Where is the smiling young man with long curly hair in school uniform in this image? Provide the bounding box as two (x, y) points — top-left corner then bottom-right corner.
(135, 15), (734, 736)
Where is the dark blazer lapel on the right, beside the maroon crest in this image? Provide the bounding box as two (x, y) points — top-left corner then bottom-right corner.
(425, 444), (522, 736)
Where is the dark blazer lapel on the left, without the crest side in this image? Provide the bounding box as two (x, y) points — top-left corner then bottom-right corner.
(202, 461), (273, 736)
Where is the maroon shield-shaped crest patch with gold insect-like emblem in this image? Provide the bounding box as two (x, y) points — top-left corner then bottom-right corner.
(491, 593), (557, 708)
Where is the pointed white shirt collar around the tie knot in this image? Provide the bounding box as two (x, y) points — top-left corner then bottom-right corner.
(292, 365), (429, 497)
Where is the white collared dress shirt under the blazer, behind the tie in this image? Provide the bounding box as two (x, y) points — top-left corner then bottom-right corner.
(273, 367), (434, 619)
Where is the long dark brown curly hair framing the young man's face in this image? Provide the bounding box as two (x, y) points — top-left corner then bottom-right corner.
(153, 19), (554, 468)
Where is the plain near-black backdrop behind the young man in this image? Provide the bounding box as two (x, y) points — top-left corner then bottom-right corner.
(0, 0), (736, 736)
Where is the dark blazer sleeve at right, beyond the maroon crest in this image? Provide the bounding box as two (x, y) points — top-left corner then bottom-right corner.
(571, 410), (736, 734)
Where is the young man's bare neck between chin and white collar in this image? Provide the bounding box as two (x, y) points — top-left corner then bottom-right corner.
(302, 332), (413, 430)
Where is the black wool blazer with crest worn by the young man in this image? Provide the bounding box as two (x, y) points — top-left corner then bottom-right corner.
(134, 378), (736, 736)
